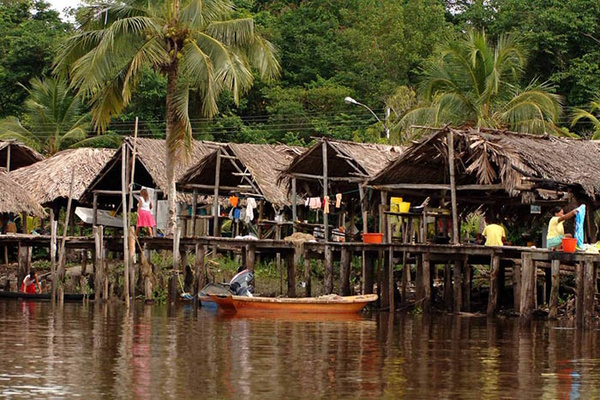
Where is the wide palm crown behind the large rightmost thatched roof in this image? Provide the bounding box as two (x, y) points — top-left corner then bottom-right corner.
(395, 31), (562, 144)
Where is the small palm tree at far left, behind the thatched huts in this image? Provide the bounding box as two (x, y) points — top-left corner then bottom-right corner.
(0, 78), (101, 155)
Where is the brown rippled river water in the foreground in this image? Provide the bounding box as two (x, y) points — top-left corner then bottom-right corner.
(0, 300), (600, 399)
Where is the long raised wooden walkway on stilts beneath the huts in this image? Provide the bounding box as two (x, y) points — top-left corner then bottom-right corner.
(0, 234), (600, 327)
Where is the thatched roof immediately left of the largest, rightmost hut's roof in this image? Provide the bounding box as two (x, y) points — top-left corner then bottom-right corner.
(281, 138), (403, 196)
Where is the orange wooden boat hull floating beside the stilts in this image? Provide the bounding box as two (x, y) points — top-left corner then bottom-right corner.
(209, 294), (377, 314)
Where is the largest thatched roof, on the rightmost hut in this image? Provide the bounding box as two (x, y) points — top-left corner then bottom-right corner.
(369, 128), (600, 203)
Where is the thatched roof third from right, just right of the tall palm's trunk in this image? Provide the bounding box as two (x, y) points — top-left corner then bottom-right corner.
(179, 143), (303, 206)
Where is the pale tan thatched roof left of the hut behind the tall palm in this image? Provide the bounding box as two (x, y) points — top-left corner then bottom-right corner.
(10, 148), (115, 205)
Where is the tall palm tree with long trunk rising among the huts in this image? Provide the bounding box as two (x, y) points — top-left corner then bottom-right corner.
(55, 0), (279, 233)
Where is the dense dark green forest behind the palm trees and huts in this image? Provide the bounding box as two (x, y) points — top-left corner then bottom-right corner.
(0, 0), (600, 150)
